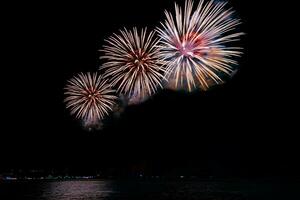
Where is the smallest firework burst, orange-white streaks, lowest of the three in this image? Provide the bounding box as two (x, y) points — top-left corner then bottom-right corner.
(64, 72), (117, 127)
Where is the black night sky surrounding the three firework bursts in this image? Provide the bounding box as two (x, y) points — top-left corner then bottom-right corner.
(0, 0), (299, 176)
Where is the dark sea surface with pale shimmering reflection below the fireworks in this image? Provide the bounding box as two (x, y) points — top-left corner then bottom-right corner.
(0, 180), (300, 200)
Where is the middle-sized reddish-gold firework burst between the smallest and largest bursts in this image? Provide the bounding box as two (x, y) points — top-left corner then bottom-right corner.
(100, 28), (164, 103)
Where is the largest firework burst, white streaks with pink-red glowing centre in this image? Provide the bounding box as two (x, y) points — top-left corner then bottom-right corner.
(157, 0), (243, 91)
